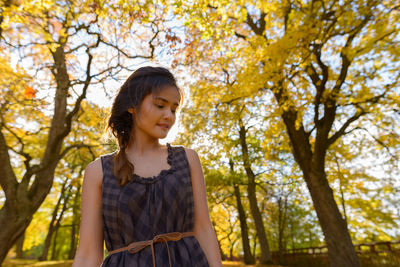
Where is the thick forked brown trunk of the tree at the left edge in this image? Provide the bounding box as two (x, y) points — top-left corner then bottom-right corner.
(0, 40), (92, 264)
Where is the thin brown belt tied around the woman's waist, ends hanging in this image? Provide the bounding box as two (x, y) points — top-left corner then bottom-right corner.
(108, 232), (194, 267)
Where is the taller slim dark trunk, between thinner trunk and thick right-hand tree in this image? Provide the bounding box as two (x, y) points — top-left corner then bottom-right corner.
(239, 124), (272, 264)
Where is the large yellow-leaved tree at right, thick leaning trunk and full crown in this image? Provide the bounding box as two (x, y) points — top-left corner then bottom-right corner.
(177, 0), (400, 267)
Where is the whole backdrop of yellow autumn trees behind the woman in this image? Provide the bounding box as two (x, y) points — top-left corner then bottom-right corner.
(0, 0), (400, 266)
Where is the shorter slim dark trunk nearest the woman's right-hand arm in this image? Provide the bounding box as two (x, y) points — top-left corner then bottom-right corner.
(233, 184), (255, 264)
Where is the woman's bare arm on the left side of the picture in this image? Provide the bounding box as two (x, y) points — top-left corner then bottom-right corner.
(72, 159), (104, 267)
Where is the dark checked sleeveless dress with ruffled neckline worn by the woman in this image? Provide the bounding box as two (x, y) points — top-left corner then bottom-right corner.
(101, 146), (209, 267)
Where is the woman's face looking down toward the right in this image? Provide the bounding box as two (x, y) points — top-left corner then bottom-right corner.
(134, 86), (181, 139)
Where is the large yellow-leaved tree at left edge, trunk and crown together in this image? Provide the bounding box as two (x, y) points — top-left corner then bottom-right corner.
(0, 0), (173, 263)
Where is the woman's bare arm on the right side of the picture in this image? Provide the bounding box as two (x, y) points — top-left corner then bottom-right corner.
(185, 148), (222, 267)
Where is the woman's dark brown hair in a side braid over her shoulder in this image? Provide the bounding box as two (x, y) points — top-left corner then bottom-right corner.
(107, 67), (182, 186)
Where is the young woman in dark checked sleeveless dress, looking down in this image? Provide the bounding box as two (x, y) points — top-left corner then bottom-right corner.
(72, 67), (222, 267)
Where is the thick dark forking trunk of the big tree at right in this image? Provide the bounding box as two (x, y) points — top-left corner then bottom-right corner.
(274, 88), (360, 267)
